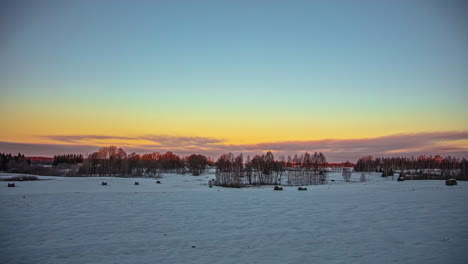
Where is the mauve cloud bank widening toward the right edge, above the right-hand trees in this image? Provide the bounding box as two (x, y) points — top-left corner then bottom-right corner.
(226, 131), (468, 160)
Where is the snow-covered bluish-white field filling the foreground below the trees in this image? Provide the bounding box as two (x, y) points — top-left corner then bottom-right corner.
(0, 174), (468, 264)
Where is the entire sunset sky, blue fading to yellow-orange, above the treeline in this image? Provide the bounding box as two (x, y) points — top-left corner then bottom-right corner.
(0, 0), (468, 161)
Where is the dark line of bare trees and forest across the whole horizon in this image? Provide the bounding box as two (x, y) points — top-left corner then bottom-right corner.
(0, 146), (468, 182)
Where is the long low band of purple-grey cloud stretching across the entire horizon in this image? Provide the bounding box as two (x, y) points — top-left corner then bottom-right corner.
(0, 131), (468, 161)
